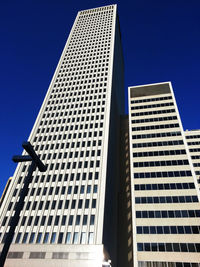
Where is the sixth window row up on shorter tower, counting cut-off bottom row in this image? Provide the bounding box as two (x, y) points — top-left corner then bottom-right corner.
(135, 183), (195, 191)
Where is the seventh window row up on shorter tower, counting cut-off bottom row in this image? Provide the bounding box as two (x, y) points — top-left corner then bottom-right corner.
(134, 171), (192, 179)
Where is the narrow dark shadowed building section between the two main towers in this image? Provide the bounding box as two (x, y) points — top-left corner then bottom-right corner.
(117, 115), (133, 267)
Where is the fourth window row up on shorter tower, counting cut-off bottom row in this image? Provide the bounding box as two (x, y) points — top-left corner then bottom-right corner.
(136, 210), (200, 218)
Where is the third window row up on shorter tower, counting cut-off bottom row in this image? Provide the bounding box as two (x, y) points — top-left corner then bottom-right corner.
(137, 225), (200, 235)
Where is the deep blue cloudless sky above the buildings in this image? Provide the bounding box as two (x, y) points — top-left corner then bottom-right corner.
(0, 0), (200, 195)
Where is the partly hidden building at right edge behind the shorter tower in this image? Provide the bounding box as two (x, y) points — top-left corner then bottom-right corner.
(185, 130), (200, 192)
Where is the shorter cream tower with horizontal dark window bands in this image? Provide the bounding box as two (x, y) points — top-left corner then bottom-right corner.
(129, 82), (200, 267)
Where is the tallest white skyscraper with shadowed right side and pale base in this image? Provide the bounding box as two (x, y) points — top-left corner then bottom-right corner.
(0, 5), (124, 267)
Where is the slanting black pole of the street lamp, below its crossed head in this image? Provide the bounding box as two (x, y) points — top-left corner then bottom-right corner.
(0, 161), (36, 267)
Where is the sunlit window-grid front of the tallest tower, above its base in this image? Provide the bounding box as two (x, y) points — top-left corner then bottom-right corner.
(0, 5), (116, 248)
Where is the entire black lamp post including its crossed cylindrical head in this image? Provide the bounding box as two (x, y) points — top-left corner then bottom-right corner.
(0, 142), (47, 267)
